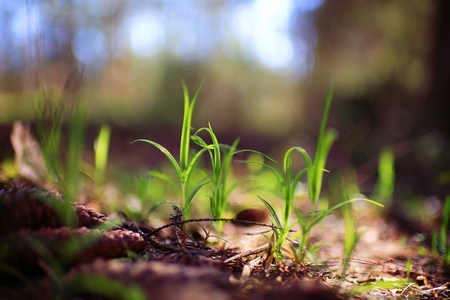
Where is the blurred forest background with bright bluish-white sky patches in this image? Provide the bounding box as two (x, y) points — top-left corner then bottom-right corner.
(0, 0), (450, 204)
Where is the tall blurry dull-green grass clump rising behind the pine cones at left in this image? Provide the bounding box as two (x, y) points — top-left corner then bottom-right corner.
(37, 72), (88, 225)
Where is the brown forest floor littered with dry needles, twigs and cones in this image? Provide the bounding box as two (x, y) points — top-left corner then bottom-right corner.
(0, 178), (450, 300)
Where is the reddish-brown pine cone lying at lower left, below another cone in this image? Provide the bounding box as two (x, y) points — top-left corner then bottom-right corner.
(0, 227), (145, 277)
